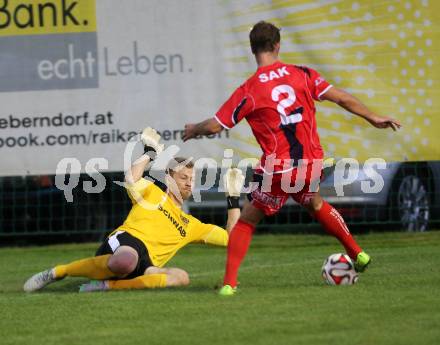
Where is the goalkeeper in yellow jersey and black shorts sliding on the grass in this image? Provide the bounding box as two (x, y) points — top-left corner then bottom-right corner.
(23, 128), (244, 292)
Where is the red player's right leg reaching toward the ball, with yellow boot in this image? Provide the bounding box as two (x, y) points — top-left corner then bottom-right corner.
(300, 193), (371, 272)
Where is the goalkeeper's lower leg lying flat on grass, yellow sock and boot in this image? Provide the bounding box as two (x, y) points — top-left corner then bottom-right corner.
(79, 266), (190, 292)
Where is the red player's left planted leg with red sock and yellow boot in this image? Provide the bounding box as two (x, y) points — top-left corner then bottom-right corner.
(219, 201), (264, 295)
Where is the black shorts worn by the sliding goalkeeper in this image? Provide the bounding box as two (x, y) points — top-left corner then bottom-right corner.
(95, 231), (154, 279)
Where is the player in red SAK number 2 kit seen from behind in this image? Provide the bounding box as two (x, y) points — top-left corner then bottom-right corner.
(184, 22), (400, 295)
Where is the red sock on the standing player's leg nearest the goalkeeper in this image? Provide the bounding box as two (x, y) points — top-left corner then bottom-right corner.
(223, 220), (255, 287)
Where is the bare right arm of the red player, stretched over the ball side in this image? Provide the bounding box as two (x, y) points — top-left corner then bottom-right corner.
(320, 87), (402, 131)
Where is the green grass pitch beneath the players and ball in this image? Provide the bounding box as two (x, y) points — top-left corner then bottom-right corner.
(0, 231), (440, 345)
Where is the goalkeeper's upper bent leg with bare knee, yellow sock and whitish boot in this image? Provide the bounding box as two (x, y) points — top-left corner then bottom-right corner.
(23, 246), (138, 292)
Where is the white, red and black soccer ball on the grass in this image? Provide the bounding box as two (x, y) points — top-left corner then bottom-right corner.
(322, 253), (359, 285)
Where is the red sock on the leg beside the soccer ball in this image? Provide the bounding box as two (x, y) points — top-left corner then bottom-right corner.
(315, 201), (362, 260)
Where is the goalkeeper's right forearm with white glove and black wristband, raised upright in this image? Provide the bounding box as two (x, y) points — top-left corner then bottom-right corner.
(224, 168), (245, 232)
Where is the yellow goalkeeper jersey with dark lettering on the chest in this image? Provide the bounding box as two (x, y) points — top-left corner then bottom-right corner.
(117, 178), (228, 267)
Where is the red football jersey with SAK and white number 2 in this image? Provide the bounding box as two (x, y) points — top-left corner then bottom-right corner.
(215, 61), (332, 174)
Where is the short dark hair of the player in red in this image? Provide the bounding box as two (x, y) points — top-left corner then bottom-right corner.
(249, 21), (281, 55)
